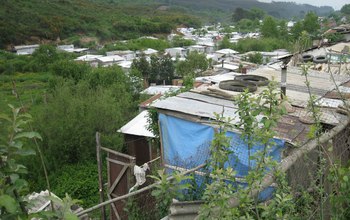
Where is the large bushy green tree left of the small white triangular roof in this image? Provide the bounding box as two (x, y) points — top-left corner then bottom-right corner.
(33, 67), (138, 171)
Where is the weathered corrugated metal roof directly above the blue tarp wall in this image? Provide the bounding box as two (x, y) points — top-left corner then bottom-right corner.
(151, 67), (350, 143)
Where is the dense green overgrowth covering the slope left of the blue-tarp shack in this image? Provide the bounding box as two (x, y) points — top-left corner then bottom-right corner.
(0, 45), (142, 211)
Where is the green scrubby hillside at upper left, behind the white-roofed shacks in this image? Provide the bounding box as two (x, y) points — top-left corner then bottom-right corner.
(0, 0), (200, 49)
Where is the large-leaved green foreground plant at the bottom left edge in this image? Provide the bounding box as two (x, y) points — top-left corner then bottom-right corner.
(0, 105), (78, 219)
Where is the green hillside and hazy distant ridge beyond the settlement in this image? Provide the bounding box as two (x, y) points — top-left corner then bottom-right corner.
(0, 0), (333, 49)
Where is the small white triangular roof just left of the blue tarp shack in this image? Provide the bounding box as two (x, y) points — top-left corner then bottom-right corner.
(118, 111), (155, 138)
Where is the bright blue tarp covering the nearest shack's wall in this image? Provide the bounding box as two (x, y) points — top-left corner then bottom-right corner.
(159, 114), (284, 199)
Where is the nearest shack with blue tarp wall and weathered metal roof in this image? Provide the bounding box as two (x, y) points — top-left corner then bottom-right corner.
(152, 65), (350, 199)
